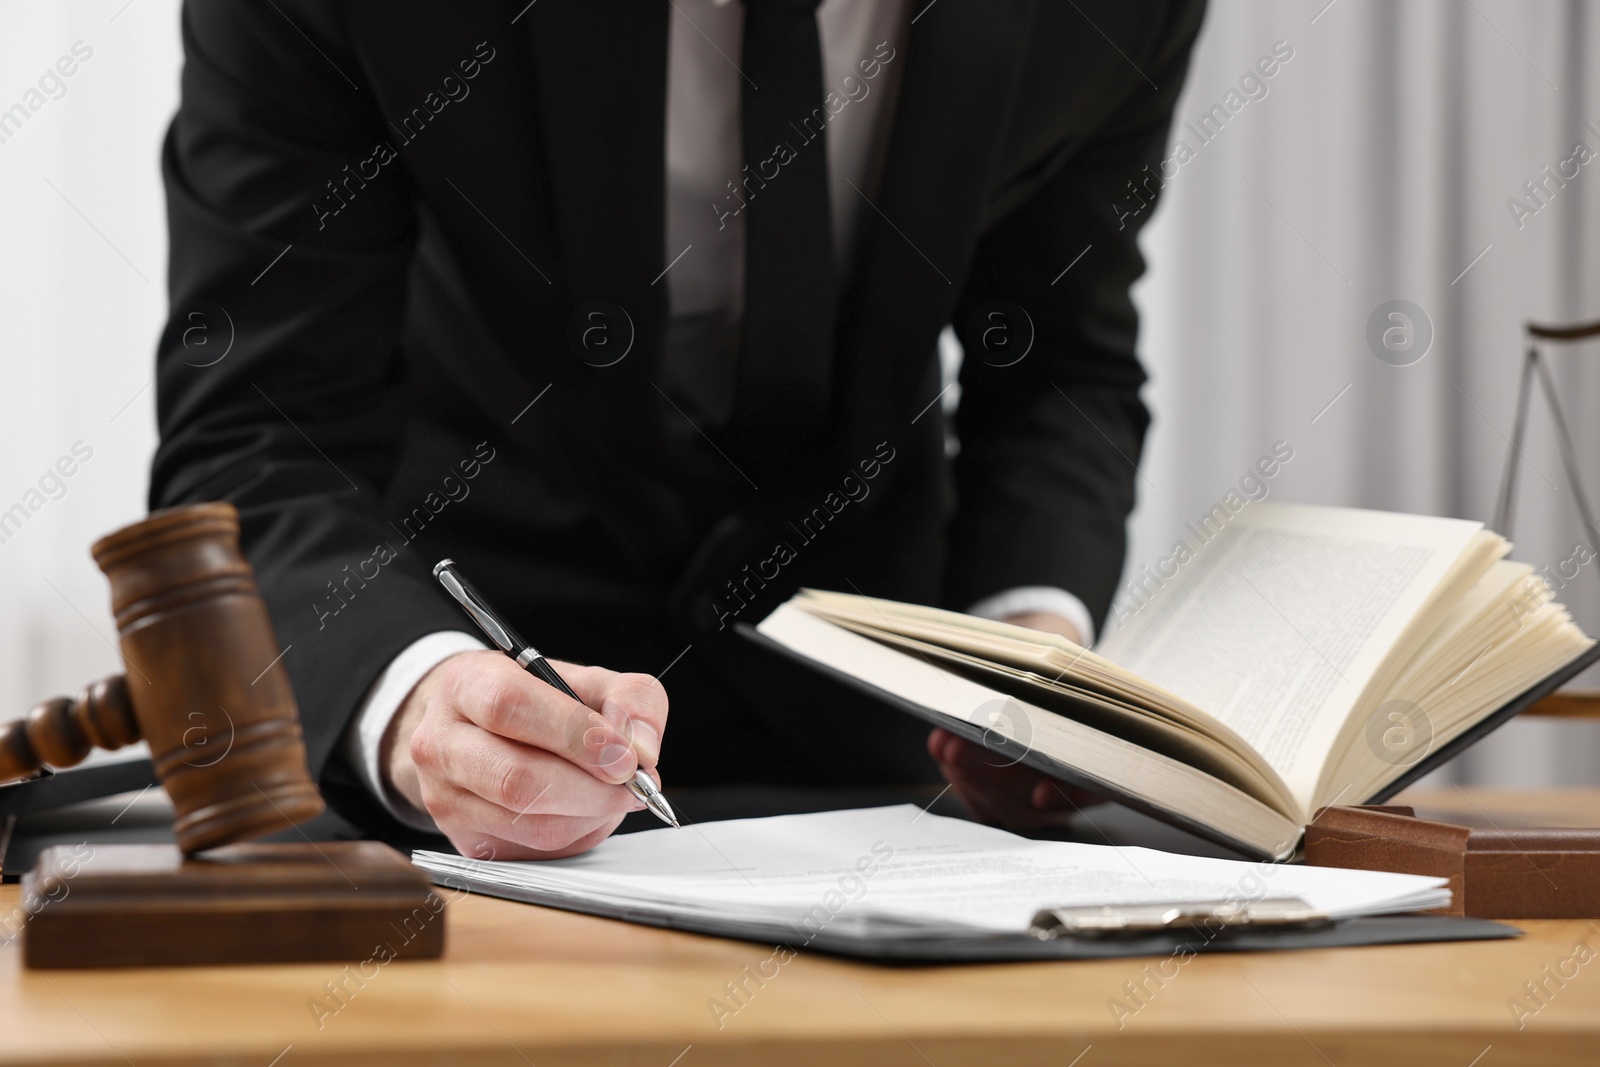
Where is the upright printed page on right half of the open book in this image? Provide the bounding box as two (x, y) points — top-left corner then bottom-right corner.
(1096, 504), (1482, 805)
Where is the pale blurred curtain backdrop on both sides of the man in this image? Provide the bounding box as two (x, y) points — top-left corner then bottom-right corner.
(0, 0), (1600, 785)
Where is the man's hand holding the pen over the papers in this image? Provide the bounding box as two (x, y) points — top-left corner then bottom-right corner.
(379, 651), (667, 859)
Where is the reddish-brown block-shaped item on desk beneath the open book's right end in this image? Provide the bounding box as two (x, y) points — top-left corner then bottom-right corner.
(1306, 805), (1600, 918)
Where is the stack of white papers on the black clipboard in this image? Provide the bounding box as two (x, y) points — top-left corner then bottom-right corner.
(413, 805), (1450, 937)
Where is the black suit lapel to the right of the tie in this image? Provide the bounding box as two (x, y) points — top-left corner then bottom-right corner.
(835, 0), (1034, 462)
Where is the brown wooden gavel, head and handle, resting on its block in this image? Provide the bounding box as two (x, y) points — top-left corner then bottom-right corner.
(0, 504), (323, 854)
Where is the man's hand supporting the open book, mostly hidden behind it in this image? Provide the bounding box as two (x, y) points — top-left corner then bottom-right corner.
(928, 613), (1101, 830)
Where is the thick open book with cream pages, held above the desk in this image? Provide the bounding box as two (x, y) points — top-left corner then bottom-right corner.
(757, 504), (1600, 859)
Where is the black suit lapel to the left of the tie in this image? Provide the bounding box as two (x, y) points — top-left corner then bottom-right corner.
(510, 0), (723, 571)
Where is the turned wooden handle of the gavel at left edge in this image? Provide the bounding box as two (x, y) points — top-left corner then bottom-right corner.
(0, 675), (139, 782)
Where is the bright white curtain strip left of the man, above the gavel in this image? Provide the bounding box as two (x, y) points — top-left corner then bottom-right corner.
(0, 0), (179, 718)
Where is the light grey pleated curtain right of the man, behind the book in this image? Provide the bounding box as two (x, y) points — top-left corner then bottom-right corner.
(1130, 0), (1600, 785)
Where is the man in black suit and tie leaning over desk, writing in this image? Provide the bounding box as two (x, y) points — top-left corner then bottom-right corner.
(150, 0), (1202, 856)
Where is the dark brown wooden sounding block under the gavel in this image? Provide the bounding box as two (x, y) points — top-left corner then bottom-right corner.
(22, 841), (445, 968)
